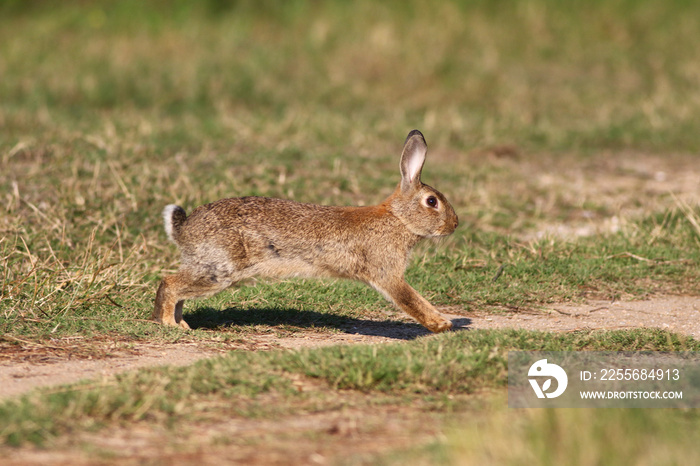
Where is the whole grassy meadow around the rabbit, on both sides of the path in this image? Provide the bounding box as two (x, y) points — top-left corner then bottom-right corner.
(0, 0), (700, 464)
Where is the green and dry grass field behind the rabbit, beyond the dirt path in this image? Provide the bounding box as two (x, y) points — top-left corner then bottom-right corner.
(0, 0), (700, 338)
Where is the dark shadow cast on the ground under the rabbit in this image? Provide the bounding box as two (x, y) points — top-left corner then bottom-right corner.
(184, 307), (471, 340)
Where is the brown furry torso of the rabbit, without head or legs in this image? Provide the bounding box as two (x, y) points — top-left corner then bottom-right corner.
(166, 197), (419, 284)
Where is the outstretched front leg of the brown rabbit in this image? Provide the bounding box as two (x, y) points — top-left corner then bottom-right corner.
(373, 278), (452, 333)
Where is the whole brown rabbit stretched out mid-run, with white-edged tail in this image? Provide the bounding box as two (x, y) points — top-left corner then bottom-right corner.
(153, 130), (458, 332)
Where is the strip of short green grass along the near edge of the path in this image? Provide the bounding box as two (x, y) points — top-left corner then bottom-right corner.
(0, 330), (700, 445)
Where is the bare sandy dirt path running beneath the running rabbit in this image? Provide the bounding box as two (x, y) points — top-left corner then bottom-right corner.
(0, 296), (700, 399)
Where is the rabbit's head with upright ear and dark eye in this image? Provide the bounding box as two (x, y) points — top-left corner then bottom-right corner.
(390, 130), (459, 238)
